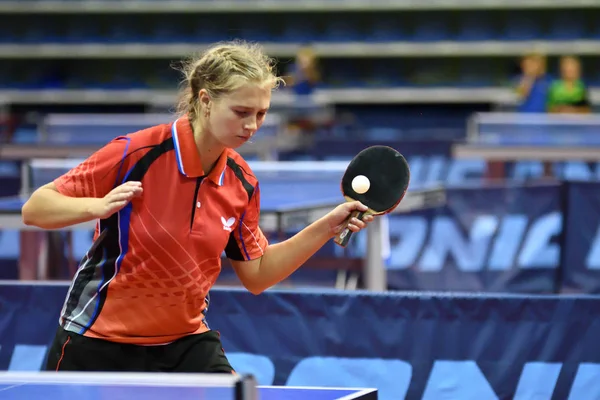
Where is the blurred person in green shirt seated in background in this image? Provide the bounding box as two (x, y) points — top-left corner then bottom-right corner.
(547, 56), (590, 113)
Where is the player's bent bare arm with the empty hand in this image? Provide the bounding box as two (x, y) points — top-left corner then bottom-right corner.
(21, 182), (142, 229)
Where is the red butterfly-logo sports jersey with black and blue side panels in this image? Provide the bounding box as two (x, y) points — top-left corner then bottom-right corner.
(55, 117), (267, 344)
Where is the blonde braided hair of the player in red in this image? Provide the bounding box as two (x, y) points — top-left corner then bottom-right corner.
(177, 40), (283, 119)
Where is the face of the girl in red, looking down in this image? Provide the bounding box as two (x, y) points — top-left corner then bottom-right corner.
(207, 83), (271, 149)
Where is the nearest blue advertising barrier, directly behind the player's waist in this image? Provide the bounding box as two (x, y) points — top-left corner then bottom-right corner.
(0, 284), (600, 400)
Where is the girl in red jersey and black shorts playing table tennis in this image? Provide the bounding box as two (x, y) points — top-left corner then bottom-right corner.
(22, 42), (372, 372)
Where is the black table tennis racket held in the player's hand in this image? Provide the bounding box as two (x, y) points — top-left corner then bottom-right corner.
(334, 146), (410, 247)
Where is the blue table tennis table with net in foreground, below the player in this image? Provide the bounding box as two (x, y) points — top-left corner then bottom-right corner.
(0, 371), (377, 400)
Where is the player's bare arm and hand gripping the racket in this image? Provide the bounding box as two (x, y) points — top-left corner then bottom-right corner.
(231, 202), (373, 294)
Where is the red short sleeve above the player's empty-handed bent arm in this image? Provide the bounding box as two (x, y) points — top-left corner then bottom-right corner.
(54, 137), (130, 198)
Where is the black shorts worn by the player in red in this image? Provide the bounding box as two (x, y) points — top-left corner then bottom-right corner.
(46, 327), (233, 374)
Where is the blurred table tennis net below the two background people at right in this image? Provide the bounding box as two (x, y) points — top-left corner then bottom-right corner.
(468, 113), (600, 147)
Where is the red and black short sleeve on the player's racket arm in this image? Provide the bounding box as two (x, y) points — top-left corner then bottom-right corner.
(225, 183), (269, 261)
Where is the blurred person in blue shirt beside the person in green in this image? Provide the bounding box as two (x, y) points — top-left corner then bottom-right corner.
(516, 53), (551, 113)
